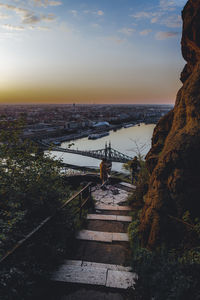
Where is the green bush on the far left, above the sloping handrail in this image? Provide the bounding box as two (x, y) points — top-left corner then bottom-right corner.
(0, 123), (69, 257)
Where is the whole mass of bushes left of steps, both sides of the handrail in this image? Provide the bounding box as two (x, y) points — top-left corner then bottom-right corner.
(0, 122), (80, 300)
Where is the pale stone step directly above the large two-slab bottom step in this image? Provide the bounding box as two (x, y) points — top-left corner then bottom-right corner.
(76, 230), (129, 243)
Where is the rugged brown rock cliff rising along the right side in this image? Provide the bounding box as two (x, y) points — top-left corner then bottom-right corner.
(140, 0), (200, 248)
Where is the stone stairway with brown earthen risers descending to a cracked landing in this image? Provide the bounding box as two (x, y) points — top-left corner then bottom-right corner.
(52, 183), (137, 300)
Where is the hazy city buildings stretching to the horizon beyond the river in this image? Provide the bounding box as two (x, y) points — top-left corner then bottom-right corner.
(0, 104), (172, 141)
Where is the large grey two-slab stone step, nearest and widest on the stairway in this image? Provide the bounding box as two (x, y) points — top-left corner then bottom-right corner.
(51, 261), (138, 289)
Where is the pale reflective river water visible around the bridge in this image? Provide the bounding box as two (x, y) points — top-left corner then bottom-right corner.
(50, 124), (155, 172)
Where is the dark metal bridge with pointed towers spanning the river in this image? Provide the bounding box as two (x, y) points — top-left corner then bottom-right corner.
(39, 141), (132, 163)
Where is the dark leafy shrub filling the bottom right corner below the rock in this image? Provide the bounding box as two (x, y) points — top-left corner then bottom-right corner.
(132, 248), (200, 300)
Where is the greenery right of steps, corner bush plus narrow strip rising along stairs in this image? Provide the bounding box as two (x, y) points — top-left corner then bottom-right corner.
(129, 211), (200, 300)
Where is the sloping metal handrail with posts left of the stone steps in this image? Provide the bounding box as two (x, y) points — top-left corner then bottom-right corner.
(0, 182), (92, 264)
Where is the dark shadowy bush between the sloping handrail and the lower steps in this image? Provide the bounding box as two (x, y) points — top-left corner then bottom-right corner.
(0, 210), (77, 300)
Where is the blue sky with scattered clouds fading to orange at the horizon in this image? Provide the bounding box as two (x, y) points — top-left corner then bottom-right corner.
(0, 0), (186, 104)
